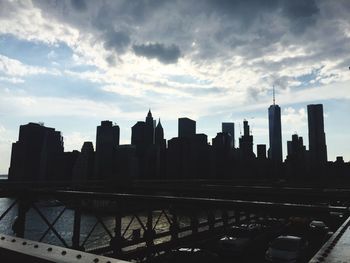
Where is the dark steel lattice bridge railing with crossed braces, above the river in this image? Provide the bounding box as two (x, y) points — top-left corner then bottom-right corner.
(0, 189), (349, 259)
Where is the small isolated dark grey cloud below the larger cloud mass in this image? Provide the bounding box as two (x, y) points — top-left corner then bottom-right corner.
(133, 43), (181, 64)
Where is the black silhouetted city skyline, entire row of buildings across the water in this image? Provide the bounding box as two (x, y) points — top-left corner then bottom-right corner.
(8, 104), (350, 182)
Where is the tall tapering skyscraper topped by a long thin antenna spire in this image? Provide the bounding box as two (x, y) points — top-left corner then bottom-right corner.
(268, 87), (282, 162)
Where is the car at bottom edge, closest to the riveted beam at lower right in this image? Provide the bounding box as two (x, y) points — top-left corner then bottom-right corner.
(265, 236), (308, 263)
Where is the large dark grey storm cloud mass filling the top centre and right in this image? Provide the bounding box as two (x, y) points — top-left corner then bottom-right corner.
(30, 0), (350, 75)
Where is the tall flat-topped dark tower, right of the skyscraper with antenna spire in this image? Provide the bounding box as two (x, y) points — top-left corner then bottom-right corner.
(307, 104), (327, 163)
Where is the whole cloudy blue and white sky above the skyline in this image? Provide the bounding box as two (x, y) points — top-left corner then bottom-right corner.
(0, 0), (350, 174)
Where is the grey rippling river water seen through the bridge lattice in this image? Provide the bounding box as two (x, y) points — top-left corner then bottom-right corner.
(0, 198), (194, 250)
